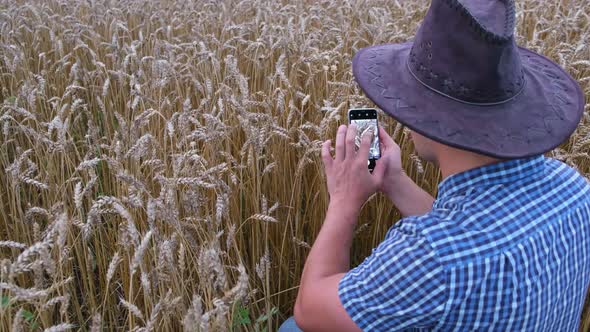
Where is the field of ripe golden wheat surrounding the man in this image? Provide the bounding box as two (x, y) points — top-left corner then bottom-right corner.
(0, 0), (590, 331)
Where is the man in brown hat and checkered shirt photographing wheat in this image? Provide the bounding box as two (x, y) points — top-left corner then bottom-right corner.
(280, 0), (590, 331)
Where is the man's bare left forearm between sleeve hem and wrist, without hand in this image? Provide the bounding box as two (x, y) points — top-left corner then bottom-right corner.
(294, 201), (360, 331)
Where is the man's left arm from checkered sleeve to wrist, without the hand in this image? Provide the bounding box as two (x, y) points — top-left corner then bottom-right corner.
(295, 193), (448, 332)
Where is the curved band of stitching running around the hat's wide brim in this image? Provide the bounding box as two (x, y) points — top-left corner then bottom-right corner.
(365, 49), (571, 151)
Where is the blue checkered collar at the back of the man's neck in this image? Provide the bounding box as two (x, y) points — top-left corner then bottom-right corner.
(437, 154), (545, 200)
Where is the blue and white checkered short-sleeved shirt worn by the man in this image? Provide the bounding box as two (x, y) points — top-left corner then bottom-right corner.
(338, 155), (590, 331)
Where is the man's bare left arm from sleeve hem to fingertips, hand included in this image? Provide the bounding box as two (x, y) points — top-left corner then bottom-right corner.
(295, 124), (386, 331)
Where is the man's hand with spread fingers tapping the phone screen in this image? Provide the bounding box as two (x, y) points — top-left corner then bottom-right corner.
(322, 124), (388, 208)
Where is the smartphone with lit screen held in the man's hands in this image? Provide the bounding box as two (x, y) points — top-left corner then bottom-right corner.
(348, 108), (381, 172)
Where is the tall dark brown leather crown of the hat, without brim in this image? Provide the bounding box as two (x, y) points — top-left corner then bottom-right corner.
(407, 0), (525, 104)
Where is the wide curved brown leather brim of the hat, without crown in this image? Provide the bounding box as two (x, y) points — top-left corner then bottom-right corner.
(352, 42), (584, 158)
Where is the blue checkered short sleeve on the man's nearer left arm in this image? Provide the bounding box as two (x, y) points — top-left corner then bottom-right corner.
(338, 221), (448, 331)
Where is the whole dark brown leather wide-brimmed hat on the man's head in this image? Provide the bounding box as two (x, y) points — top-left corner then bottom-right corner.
(352, 0), (584, 159)
